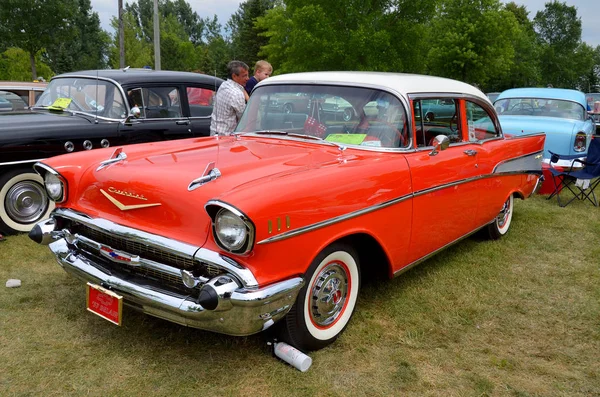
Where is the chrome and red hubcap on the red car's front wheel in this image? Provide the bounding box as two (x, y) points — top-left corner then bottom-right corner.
(310, 263), (348, 327)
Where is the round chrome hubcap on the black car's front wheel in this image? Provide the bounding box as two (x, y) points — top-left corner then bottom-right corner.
(4, 181), (49, 224)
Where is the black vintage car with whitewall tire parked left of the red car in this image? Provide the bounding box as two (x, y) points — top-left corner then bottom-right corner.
(0, 69), (222, 233)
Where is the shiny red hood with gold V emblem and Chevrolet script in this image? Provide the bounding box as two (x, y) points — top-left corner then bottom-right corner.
(69, 138), (352, 246)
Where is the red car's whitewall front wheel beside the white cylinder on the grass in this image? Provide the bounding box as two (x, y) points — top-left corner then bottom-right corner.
(280, 243), (360, 350)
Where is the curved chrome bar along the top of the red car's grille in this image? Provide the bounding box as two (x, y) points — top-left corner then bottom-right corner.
(52, 208), (258, 288)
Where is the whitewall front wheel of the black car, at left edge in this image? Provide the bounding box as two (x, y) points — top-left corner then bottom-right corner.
(0, 169), (54, 233)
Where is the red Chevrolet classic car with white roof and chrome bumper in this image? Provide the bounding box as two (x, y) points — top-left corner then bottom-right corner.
(30, 72), (545, 350)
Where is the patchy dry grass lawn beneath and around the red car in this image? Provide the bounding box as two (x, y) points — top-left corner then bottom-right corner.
(0, 196), (600, 396)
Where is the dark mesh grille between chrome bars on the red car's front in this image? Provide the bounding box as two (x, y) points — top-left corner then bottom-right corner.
(68, 222), (223, 290)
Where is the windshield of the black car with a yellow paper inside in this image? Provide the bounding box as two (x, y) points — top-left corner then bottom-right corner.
(35, 77), (127, 119)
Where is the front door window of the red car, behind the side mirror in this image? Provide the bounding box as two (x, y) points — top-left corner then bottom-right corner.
(413, 98), (463, 147)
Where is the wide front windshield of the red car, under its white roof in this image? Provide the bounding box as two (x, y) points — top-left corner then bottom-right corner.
(236, 84), (408, 148)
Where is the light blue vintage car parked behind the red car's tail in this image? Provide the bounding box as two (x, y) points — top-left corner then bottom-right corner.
(494, 88), (596, 193)
